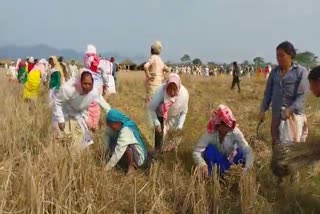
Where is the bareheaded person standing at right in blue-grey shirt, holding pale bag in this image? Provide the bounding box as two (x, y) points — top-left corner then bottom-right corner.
(260, 41), (309, 182)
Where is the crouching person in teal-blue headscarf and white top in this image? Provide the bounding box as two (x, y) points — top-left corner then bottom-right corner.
(104, 109), (147, 175)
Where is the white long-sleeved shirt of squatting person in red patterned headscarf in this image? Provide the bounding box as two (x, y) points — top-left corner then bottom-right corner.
(192, 128), (254, 168)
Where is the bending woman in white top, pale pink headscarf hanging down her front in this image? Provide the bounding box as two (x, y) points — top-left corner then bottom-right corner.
(149, 73), (189, 152)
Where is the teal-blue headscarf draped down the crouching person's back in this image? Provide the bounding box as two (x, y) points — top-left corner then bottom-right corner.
(106, 109), (147, 159)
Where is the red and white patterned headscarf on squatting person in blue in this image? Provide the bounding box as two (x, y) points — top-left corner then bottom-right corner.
(207, 105), (236, 134)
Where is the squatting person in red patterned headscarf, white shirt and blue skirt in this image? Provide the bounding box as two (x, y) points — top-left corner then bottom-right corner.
(192, 105), (254, 177)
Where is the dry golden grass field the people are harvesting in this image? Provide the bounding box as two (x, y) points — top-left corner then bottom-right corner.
(0, 70), (320, 214)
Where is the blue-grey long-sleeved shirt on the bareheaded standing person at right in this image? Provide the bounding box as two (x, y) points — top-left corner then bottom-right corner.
(261, 64), (309, 117)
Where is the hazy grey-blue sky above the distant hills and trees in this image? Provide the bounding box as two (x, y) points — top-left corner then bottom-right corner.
(0, 0), (320, 62)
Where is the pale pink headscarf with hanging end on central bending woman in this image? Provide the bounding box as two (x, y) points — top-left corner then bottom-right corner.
(161, 74), (181, 119)
